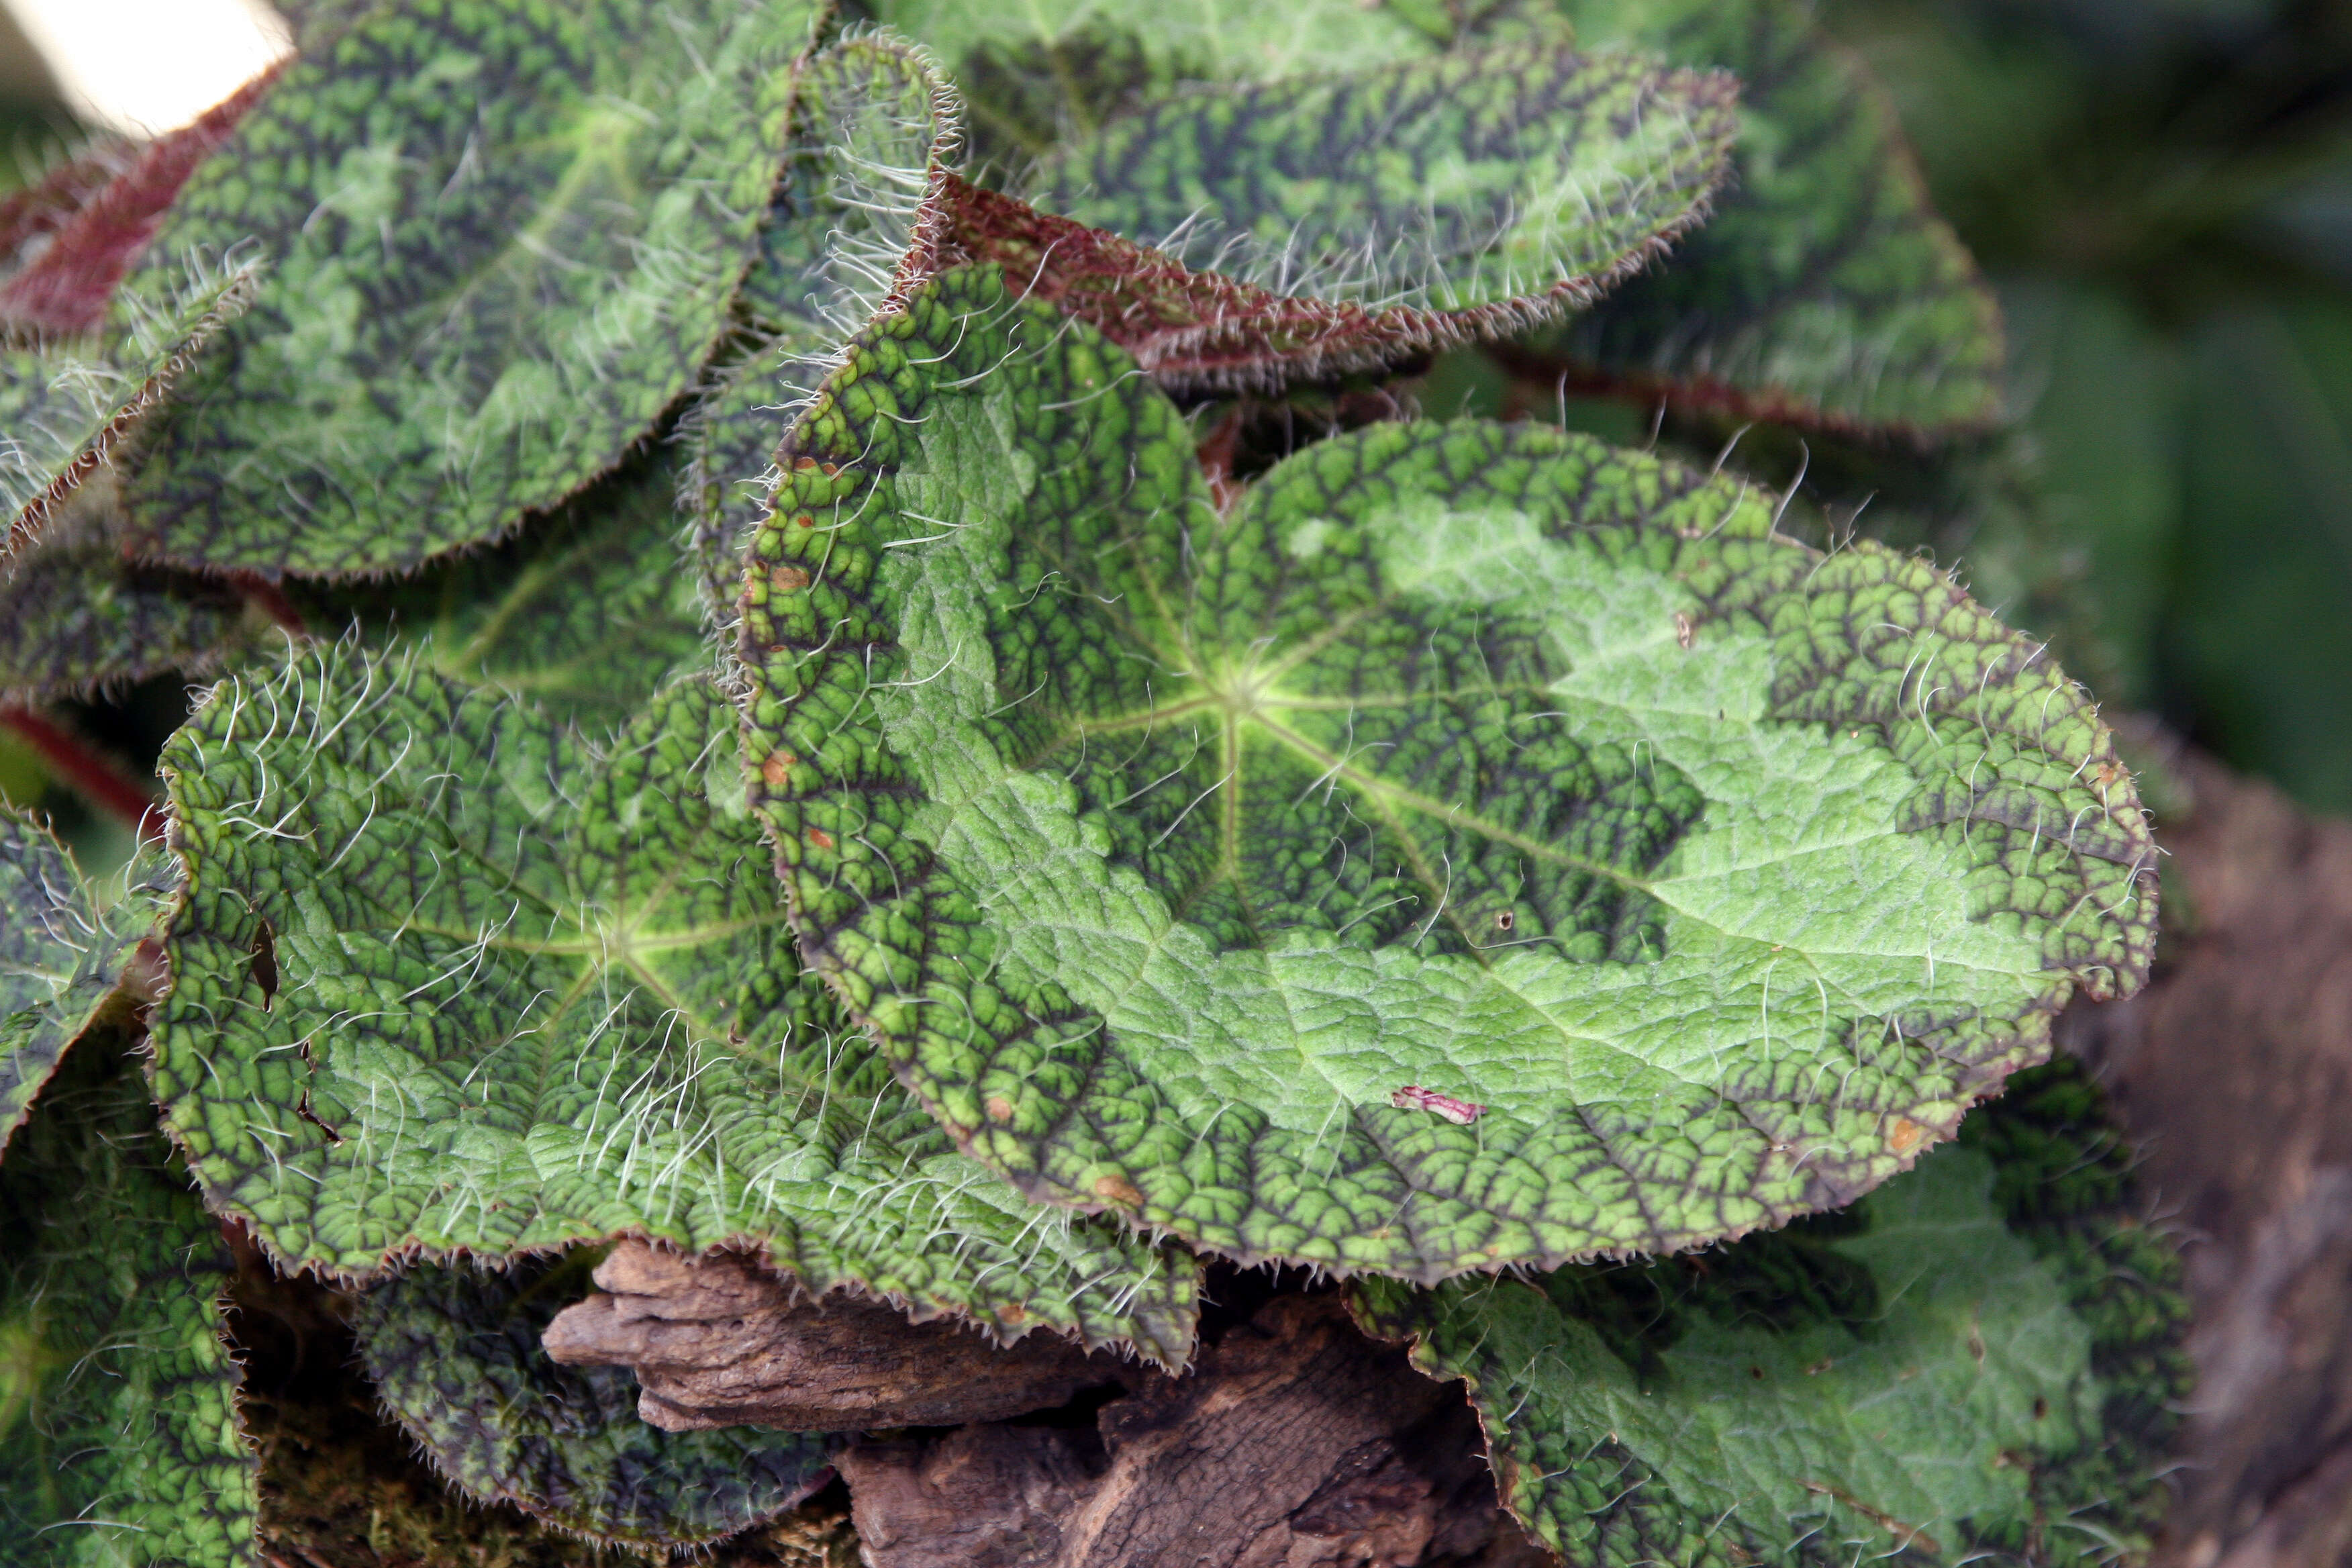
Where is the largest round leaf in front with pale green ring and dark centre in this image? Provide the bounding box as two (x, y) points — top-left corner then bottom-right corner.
(743, 271), (2155, 1279)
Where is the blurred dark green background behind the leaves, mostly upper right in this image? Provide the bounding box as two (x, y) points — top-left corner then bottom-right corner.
(0, 0), (2352, 832)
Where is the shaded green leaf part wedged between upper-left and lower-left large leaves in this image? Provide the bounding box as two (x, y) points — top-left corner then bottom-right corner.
(289, 446), (710, 724)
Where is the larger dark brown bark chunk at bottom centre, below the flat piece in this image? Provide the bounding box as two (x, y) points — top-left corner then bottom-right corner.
(840, 1295), (1550, 1568)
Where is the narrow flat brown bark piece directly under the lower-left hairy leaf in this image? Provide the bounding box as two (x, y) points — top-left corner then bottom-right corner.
(541, 1241), (1126, 1432)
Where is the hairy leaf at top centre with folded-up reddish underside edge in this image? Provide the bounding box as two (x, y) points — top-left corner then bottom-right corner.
(1028, 42), (1736, 385)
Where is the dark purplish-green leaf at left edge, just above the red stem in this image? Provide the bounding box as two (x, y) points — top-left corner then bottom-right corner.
(0, 470), (271, 705)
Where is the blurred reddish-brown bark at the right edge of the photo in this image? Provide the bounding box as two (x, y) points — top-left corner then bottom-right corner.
(2063, 752), (2352, 1568)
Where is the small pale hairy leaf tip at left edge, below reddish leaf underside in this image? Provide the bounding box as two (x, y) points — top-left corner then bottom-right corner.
(0, 261), (258, 564)
